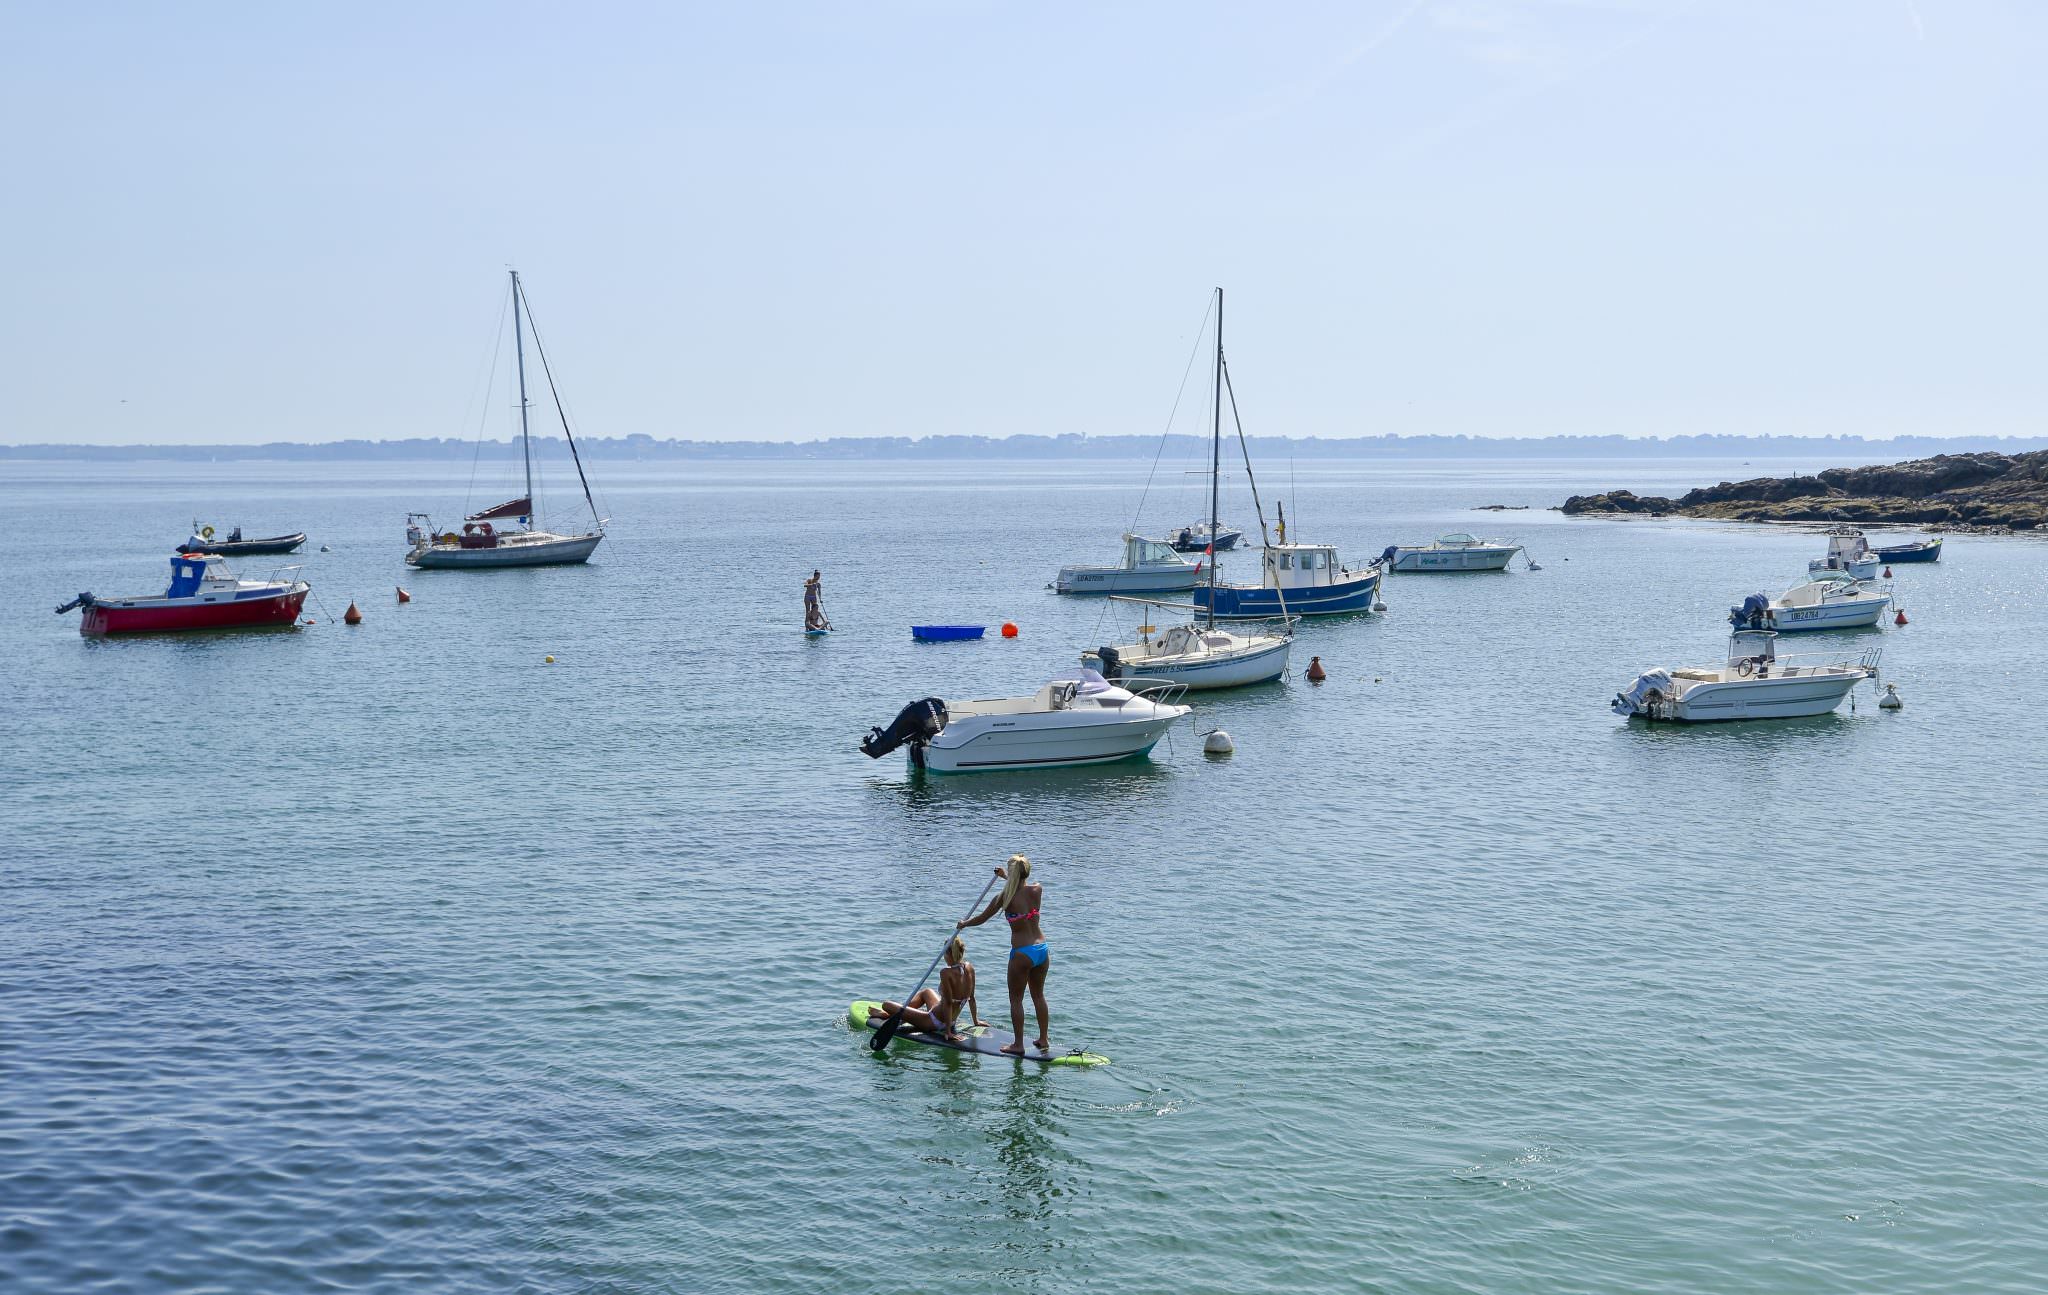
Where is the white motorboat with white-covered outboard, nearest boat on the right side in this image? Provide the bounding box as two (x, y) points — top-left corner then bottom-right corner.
(1610, 629), (1882, 723)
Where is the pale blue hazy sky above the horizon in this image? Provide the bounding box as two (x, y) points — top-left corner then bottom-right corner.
(0, 0), (2048, 445)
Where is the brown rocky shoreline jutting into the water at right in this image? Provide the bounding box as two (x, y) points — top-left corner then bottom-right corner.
(1559, 451), (2048, 531)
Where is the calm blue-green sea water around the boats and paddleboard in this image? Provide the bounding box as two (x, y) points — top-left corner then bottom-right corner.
(0, 452), (2048, 1293)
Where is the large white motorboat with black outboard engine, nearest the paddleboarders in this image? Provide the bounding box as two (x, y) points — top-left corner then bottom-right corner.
(860, 670), (1190, 772)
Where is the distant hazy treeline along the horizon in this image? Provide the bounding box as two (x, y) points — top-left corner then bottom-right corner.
(0, 434), (2048, 463)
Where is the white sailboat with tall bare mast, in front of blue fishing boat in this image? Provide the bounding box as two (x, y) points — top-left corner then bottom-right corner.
(1081, 287), (1294, 688)
